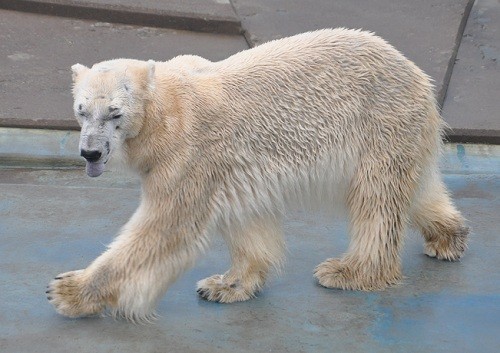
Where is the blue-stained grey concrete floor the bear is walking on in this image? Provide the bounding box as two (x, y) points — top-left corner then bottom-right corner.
(0, 140), (500, 353)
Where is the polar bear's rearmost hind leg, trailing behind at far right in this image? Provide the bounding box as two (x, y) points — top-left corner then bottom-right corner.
(411, 172), (469, 261)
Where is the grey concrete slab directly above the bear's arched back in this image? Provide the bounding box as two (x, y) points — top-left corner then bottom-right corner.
(233, 0), (473, 103)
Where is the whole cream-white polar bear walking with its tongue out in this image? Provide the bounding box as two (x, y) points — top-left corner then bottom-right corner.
(47, 28), (468, 321)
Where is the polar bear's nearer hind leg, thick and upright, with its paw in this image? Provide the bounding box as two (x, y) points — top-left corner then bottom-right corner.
(314, 161), (415, 290)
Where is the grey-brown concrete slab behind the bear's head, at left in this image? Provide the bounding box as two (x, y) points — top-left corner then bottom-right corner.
(0, 10), (248, 128)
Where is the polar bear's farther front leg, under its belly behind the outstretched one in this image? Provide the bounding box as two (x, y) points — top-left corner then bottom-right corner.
(197, 217), (284, 303)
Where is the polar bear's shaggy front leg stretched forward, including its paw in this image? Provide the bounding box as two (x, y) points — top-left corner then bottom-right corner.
(47, 192), (211, 322)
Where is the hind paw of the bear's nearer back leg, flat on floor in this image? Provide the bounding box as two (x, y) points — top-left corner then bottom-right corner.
(314, 259), (401, 291)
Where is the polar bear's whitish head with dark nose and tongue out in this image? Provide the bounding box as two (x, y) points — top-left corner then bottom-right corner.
(71, 59), (155, 177)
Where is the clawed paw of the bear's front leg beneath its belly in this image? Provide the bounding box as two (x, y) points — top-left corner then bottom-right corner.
(196, 275), (258, 303)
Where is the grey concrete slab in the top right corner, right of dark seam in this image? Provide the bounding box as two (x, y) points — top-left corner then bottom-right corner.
(443, 0), (500, 143)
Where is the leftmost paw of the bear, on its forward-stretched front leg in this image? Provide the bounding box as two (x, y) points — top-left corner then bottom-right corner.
(45, 270), (105, 318)
